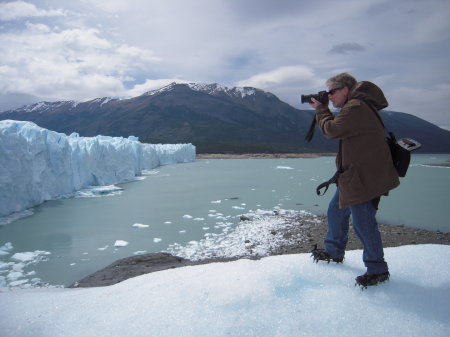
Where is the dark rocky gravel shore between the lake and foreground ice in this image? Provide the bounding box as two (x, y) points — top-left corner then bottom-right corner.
(70, 214), (450, 288)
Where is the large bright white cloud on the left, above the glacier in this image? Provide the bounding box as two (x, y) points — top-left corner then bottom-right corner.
(0, 18), (162, 100)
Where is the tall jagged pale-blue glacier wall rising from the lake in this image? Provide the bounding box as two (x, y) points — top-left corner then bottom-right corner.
(0, 120), (196, 217)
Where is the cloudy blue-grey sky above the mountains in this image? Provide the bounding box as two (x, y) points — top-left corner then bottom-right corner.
(0, 0), (450, 129)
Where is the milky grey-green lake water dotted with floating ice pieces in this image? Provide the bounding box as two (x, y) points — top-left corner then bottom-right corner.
(0, 155), (450, 285)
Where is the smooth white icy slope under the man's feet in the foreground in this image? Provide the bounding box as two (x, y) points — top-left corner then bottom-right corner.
(0, 245), (450, 337)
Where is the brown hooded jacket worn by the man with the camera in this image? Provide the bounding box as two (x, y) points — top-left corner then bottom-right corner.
(316, 81), (400, 208)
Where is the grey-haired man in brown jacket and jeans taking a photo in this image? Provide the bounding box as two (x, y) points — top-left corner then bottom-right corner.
(311, 73), (400, 288)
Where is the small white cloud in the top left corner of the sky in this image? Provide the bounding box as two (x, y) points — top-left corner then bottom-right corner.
(0, 1), (66, 21)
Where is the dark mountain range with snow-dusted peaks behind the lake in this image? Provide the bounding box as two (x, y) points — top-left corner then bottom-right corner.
(0, 83), (450, 153)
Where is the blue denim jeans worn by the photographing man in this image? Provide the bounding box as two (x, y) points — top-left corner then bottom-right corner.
(325, 188), (388, 274)
